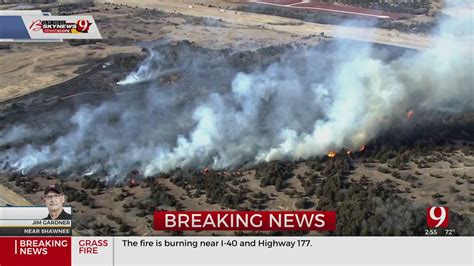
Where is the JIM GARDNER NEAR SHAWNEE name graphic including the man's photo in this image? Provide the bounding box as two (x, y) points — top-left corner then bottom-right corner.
(0, 184), (72, 236)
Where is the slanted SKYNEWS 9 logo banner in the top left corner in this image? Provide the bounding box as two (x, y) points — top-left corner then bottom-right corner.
(0, 10), (102, 42)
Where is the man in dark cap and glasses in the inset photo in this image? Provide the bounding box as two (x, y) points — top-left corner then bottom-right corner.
(43, 184), (72, 220)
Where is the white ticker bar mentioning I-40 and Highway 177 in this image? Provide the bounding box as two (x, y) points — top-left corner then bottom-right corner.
(72, 237), (474, 266)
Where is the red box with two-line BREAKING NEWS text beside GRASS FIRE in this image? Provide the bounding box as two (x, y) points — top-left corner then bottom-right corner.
(0, 237), (71, 266)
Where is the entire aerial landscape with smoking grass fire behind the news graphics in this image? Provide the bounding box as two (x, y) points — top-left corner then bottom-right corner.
(0, 0), (474, 236)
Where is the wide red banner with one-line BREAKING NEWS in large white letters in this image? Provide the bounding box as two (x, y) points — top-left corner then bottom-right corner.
(154, 211), (336, 231)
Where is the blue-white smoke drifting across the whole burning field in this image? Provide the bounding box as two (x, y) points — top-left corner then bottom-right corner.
(0, 5), (474, 181)
